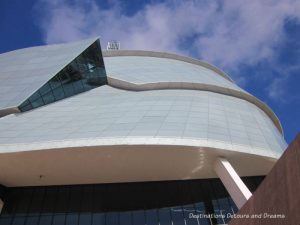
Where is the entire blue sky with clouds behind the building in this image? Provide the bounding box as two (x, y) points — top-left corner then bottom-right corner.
(0, 0), (300, 142)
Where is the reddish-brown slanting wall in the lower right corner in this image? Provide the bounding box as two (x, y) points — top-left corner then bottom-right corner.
(229, 134), (300, 225)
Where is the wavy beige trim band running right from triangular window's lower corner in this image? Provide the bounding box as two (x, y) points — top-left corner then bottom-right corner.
(107, 74), (283, 136)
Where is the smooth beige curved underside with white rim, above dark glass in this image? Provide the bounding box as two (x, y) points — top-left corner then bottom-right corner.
(0, 137), (280, 187)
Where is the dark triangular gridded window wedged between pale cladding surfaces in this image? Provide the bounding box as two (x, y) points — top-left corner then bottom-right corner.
(19, 41), (107, 112)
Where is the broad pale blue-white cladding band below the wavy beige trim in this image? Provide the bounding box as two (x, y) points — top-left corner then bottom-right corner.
(0, 85), (286, 158)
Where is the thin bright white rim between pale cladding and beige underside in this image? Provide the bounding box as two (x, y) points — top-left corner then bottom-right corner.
(0, 136), (281, 160)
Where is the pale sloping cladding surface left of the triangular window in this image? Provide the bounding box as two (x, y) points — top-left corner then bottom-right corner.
(0, 38), (98, 111)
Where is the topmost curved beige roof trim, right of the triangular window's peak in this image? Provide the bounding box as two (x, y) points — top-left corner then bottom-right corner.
(102, 50), (234, 83)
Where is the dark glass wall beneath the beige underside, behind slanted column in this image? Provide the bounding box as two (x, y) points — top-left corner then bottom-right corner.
(0, 177), (263, 225)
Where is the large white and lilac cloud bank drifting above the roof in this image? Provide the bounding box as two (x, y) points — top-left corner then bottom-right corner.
(36, 0), (300, 96)
